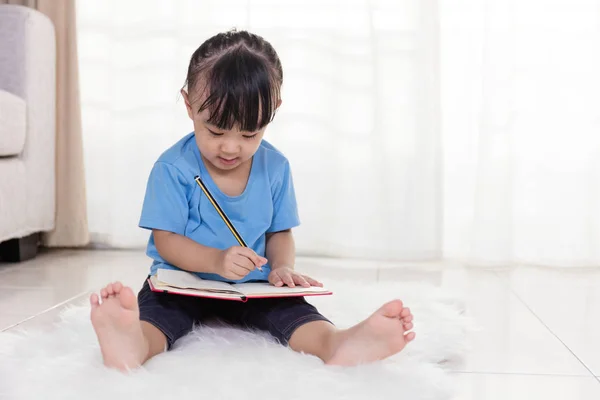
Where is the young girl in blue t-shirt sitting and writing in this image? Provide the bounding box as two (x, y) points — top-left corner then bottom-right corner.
(90, 31), (415, 370)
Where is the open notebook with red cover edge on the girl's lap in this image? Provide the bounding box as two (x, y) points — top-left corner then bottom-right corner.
(148, 269), (332, 301)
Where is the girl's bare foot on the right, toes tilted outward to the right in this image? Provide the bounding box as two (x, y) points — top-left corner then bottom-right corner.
(327, 300), (415, 365)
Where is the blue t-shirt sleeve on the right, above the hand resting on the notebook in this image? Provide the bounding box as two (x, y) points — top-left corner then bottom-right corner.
(267, 162), (300, 233)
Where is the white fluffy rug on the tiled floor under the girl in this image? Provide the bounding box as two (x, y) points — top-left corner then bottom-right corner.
(0, 282), (471, 400)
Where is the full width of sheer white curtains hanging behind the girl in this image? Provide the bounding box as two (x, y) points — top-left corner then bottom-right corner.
(77, 0), (600, 266)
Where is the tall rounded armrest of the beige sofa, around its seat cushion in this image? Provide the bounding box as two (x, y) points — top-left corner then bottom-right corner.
(0, 5), (56, 238)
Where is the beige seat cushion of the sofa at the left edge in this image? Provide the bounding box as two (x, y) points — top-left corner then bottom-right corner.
(0, 90), (27, 157)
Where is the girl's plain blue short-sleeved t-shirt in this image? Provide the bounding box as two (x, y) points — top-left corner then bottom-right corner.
(139, 132), (300, 282)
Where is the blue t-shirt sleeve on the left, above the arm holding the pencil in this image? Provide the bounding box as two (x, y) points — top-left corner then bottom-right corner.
(139, 162), (189, 235)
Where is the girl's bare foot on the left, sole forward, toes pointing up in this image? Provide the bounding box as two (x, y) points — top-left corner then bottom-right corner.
(90, 282), (148, 371)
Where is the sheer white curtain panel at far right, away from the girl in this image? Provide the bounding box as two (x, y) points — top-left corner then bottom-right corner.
(440, 0), (600, 267)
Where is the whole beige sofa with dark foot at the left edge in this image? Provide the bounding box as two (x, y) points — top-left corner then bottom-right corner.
(0, 5), (56, 261)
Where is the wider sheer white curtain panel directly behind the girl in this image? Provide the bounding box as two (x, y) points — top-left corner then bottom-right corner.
(78, 0), (440, 258)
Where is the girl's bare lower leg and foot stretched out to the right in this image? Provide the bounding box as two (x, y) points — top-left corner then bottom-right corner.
(289, 300), (415, 365)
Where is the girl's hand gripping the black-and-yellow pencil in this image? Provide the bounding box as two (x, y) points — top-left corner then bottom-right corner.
(215, 246), (267, 280)
